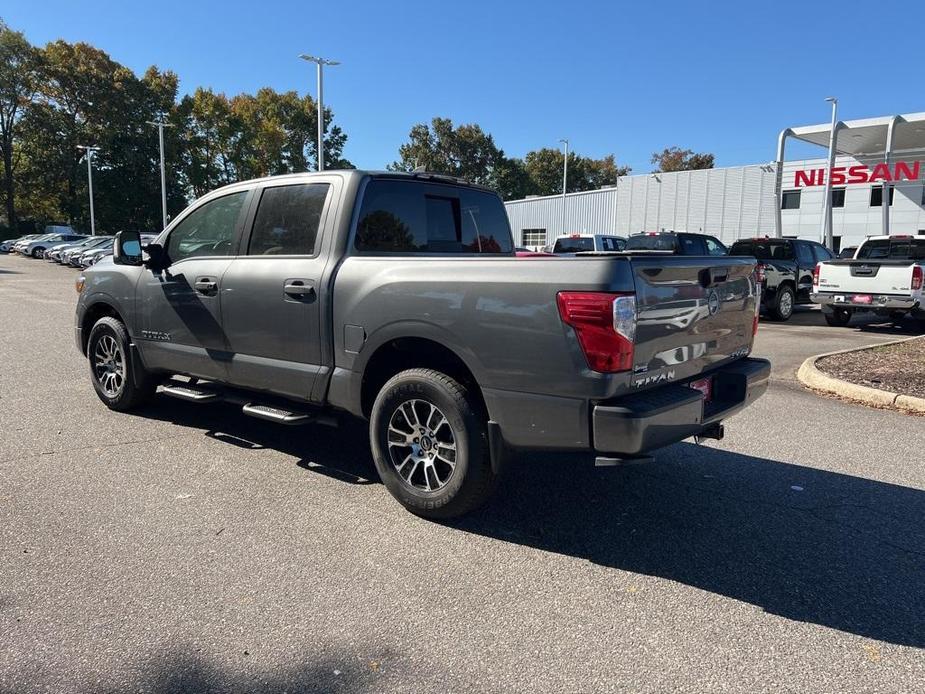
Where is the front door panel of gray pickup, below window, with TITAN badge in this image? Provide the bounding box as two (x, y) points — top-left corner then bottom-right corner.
(137, 257), (232, 380)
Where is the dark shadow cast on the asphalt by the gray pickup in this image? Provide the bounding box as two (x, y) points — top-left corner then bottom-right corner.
(137, 401), (925, 648)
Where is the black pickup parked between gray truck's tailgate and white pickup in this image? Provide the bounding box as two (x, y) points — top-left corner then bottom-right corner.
(729, 237), (835, 320)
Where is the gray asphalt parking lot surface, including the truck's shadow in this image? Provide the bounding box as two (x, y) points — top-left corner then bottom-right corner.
(0, 256), (925, 692)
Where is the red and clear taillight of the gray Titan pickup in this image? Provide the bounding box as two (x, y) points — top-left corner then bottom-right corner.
(556, 292), (636, 373)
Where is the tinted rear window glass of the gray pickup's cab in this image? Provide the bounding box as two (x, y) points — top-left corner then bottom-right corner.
(354, 179), (514, 253)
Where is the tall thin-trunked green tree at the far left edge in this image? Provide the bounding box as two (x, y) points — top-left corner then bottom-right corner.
(0, 20), (40, 229)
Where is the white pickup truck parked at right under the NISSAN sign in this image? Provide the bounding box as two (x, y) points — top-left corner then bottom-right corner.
(810, 236), (925, 326)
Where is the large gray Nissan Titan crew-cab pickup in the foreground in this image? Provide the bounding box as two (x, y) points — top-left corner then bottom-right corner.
(76, 171), (770, 518)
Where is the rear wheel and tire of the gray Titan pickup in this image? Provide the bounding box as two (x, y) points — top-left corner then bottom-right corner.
(369, 369), (496, 519)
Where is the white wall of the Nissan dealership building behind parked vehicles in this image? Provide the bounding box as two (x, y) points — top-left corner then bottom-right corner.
(505, 152), (925, 247)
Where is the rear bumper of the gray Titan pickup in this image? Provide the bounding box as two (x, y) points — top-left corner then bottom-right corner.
(591, 358), (771, 456)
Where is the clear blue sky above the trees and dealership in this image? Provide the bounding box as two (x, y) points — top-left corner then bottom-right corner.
(0, 0), (925, 172)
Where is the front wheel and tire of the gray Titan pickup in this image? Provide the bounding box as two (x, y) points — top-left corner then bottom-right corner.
(87, 316), (157, 412)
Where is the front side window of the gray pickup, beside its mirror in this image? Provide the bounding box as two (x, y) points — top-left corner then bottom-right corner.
(167, 190), (247, 263)
